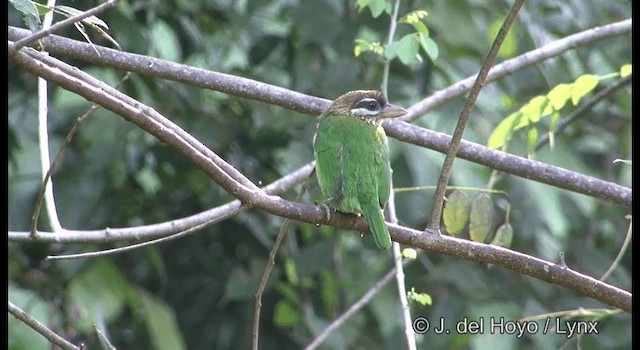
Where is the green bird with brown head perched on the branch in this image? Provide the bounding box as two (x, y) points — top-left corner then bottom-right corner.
(313, 90), (407, 249)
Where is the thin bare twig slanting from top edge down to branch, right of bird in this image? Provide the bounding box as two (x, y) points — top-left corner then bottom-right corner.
(428, 0), (524, 232)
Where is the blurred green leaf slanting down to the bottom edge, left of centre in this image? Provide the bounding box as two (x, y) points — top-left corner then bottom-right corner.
(138, 289), (187, 350)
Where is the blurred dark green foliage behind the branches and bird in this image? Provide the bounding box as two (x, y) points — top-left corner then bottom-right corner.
(8, 0), (631, 349)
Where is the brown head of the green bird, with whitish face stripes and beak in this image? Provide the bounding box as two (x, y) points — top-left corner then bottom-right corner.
(325, 90), (407, 125)
